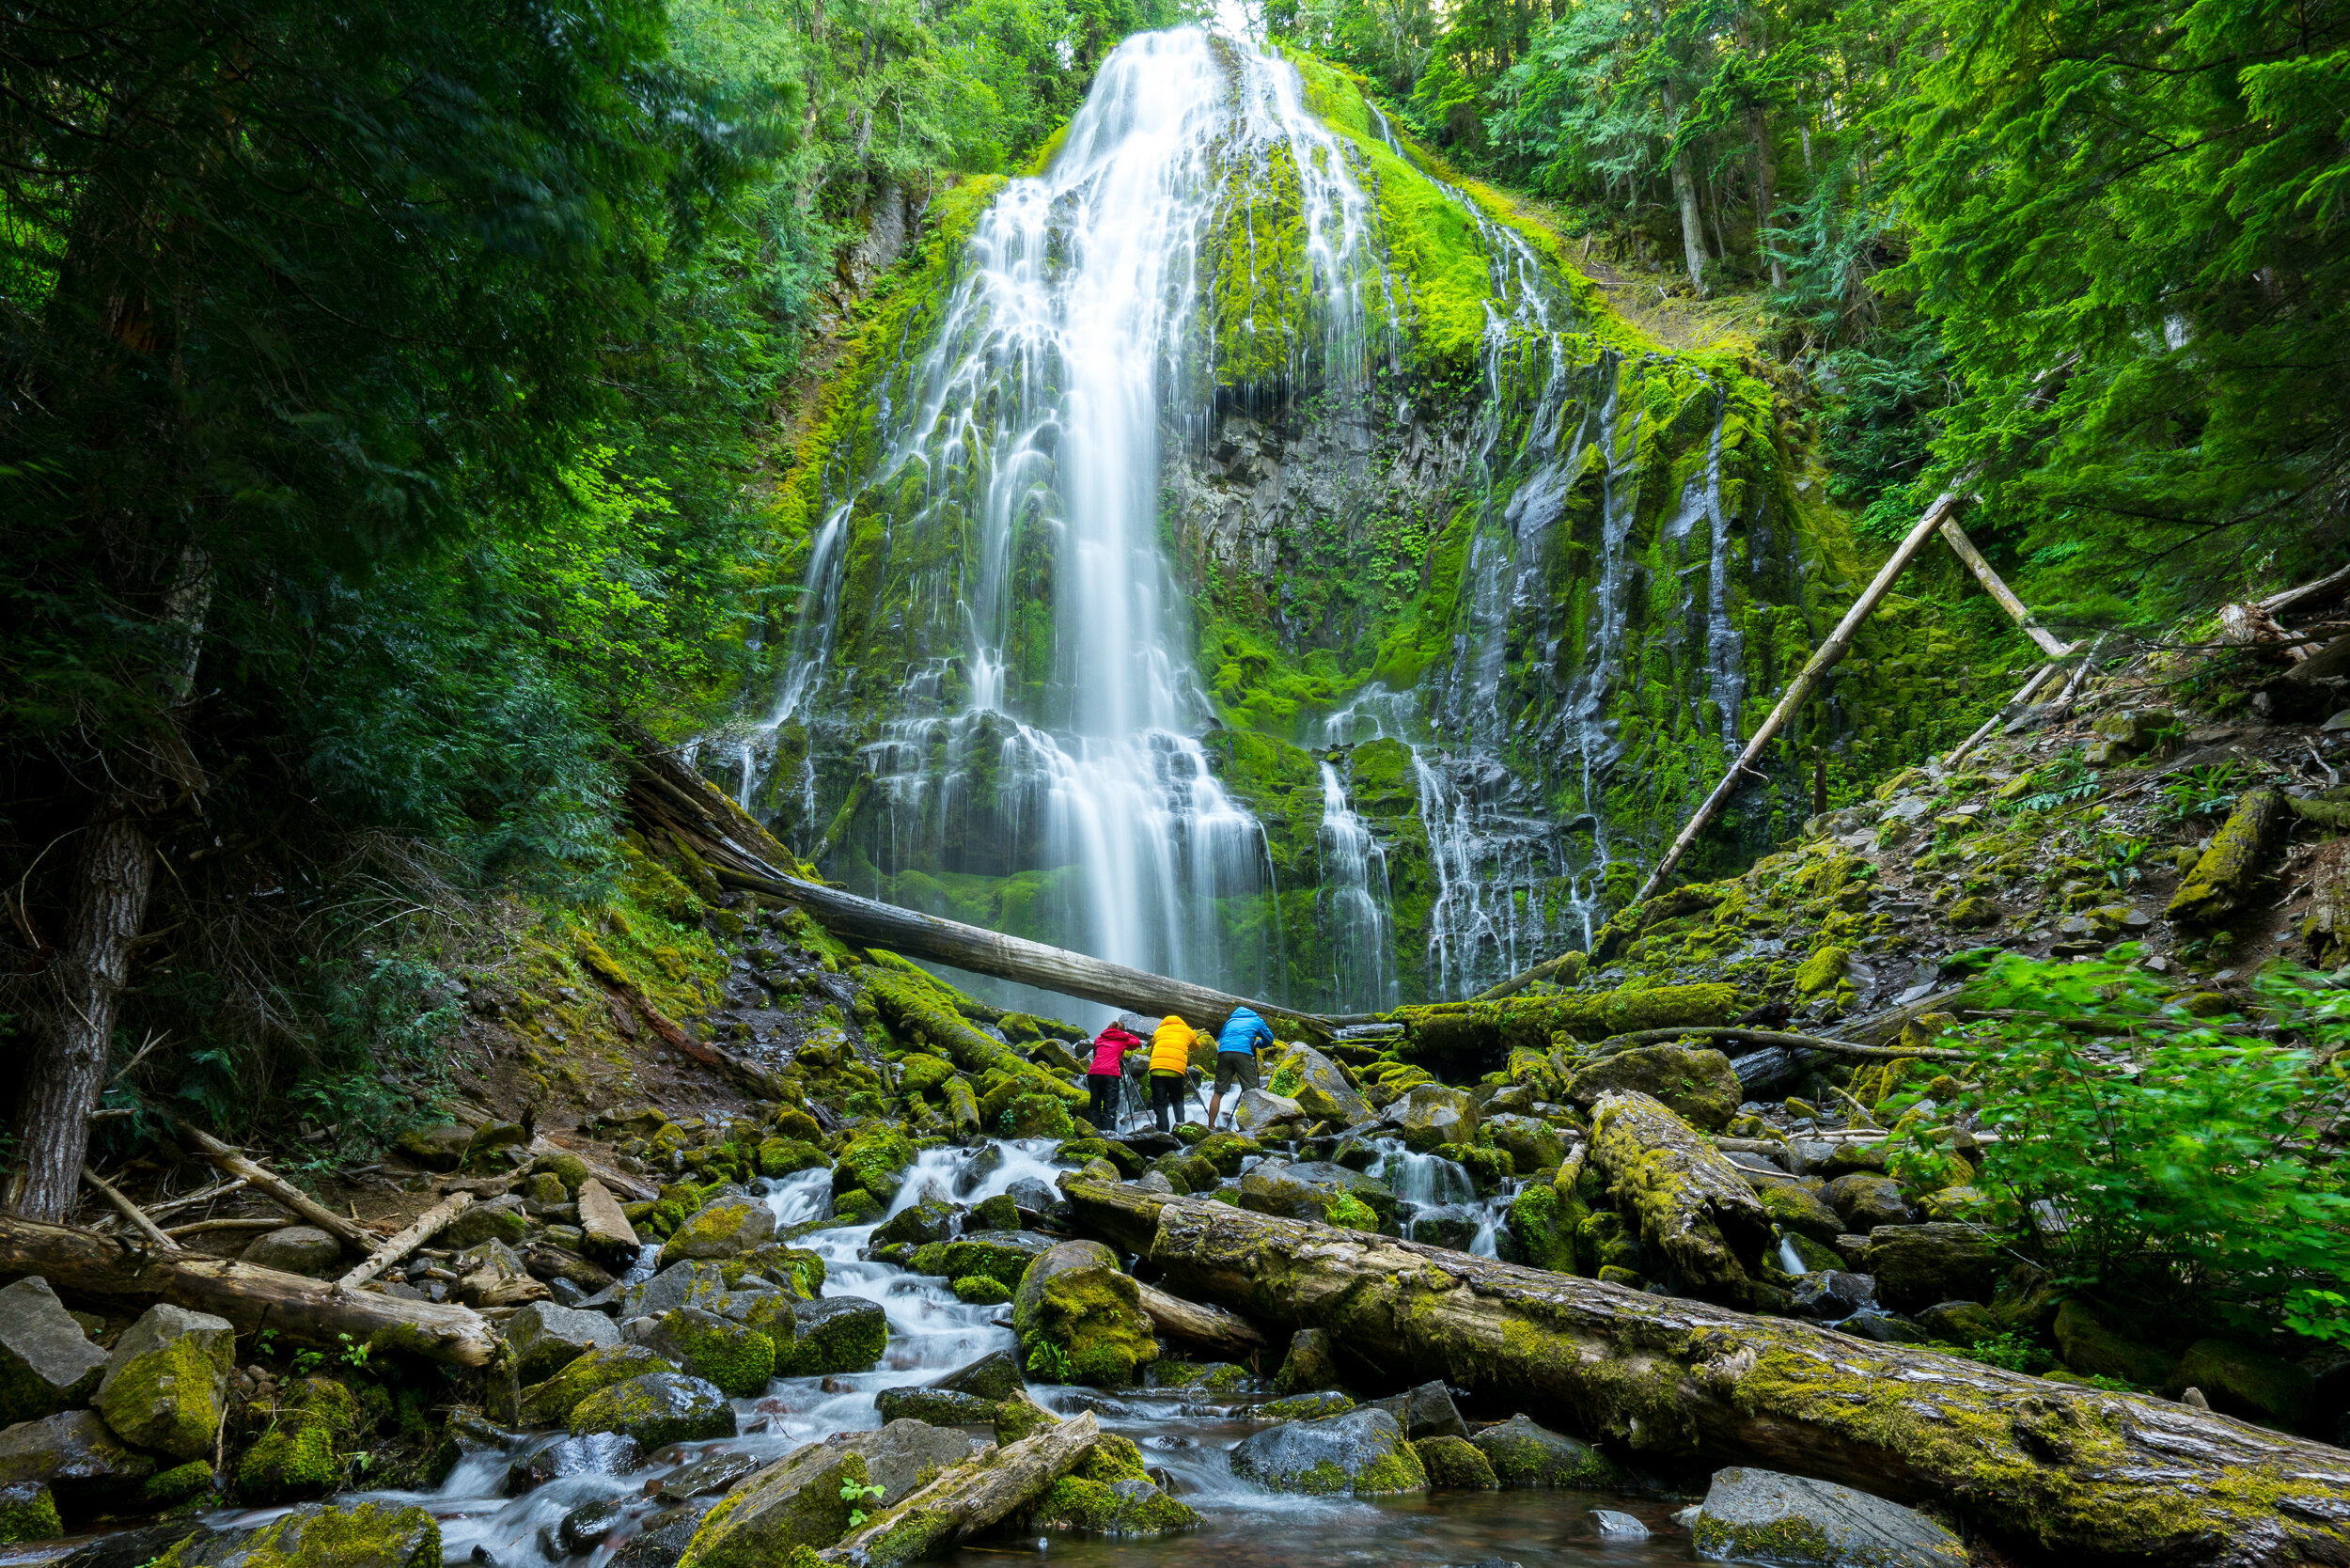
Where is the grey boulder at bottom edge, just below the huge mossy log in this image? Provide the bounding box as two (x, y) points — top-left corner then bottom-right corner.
(1695, 1469), (1967, 1568)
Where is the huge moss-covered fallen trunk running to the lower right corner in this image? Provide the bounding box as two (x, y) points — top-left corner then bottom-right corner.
(1065, 1178), (2350, 1568)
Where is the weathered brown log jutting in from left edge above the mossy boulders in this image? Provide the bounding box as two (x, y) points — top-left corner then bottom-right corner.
(0, 1215), (503, 1366)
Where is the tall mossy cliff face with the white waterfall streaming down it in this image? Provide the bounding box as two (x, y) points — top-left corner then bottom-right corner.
(698, 31), (1988, 1020)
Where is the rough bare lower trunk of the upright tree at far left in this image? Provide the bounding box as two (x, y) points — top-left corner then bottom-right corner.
(17, 785), (155, 1225)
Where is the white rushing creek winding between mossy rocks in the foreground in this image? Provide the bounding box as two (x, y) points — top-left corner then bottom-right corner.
(170, 1142), (1692, 1568)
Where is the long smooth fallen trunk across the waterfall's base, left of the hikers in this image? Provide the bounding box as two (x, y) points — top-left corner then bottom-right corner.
(633, 752), (1330, 1042)
